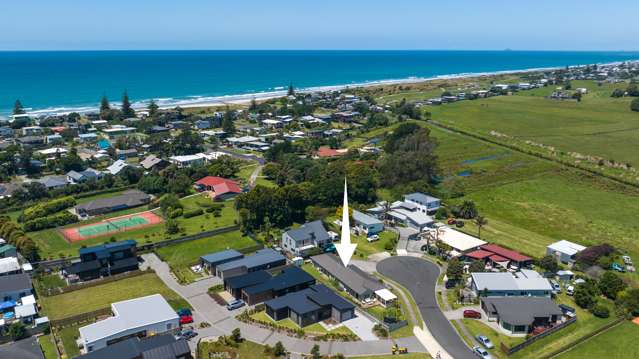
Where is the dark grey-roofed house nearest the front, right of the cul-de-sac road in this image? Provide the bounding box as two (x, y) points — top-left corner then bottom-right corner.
(481, 297), (563, 335)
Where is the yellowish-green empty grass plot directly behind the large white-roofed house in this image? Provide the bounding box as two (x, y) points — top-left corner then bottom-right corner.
(40, 273), (189, 320)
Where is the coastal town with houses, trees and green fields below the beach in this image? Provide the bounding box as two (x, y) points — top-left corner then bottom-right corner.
(0, 61), (639, 359)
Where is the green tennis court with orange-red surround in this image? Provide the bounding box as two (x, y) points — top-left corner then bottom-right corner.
(60, 212), (163, 242)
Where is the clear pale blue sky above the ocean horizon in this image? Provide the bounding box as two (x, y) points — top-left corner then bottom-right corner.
(0, 0), (639, 50)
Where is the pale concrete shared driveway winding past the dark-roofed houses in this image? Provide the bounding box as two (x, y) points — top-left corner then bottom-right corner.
(142, 253), (425, 356)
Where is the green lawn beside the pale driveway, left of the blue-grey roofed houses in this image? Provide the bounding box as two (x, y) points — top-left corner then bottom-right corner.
(156, 231), (256, 283)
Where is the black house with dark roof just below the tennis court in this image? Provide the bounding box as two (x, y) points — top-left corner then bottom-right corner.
(63, 239), (138, 281)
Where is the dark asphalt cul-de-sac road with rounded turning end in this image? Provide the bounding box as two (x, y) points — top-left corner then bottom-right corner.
(377, 257), (477, 359)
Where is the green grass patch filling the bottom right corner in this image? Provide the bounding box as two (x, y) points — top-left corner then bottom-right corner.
(557, 322), (639, 359)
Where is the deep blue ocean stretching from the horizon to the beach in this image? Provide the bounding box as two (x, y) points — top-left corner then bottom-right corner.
(0, 51), (639, 116)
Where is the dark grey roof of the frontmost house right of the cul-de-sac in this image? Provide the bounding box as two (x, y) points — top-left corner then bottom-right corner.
(481, 297), (563, 325)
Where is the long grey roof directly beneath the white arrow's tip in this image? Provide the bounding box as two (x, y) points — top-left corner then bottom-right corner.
(311, 253), (385, 295)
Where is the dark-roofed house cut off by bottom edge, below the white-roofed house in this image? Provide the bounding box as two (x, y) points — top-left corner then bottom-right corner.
(75, 334), (192, 359)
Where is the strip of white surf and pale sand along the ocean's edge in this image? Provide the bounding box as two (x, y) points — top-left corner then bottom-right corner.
(7, 60), (639, 119)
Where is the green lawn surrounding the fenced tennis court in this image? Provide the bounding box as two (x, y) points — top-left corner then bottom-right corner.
(29, 194), (237, 259)
